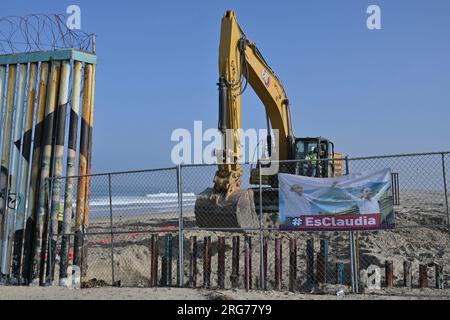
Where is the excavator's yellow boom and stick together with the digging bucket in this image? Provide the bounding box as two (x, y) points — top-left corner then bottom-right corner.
(195, 11), (294, 228)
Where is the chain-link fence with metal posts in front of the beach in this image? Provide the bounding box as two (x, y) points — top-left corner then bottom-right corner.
(44, 153), (450, 294)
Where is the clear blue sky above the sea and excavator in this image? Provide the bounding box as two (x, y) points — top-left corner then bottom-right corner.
(0, 0), (450, 172)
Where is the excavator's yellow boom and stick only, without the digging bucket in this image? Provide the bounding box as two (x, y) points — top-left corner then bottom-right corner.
(214, 11), (294, 194)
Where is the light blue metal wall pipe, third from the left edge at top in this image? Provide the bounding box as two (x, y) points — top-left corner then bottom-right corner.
(1, 64), (28, 275)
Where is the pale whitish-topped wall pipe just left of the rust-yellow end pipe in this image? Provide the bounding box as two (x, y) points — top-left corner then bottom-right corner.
(59, 61), (82, 287)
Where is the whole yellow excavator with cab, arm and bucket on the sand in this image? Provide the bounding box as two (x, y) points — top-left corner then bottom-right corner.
(195, 11), (342, 228)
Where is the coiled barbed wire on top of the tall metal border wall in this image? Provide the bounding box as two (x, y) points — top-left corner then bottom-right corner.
(0, 14), (92, 54)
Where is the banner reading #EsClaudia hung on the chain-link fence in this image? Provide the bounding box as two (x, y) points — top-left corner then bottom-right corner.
(278, 169), (395, 231)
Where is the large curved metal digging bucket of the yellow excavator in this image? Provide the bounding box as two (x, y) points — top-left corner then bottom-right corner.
(195, 189), (259, 228)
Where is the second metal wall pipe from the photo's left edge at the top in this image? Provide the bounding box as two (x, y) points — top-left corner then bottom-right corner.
(0, 65), (17, 275)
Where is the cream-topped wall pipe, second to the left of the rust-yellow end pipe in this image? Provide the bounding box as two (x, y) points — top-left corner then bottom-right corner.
(47, 61), (71, 283)
